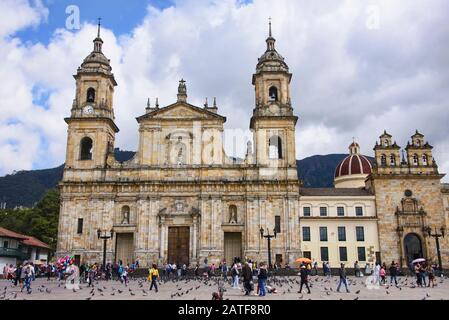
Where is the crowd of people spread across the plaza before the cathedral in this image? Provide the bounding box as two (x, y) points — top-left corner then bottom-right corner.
(3, 257), (438, 297)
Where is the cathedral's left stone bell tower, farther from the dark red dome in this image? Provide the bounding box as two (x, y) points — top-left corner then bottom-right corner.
(65, 19), (119, 169)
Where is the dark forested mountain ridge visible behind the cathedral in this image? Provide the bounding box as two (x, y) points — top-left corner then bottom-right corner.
(0, 149), (362, 208)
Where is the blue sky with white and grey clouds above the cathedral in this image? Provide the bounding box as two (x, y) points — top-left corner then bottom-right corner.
(0, 0), (449, 181)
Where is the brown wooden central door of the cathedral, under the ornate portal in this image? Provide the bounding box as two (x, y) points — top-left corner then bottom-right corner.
(168, 227), (190, 266)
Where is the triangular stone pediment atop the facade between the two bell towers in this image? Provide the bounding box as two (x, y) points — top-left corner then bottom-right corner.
(137, 102), (226, 121)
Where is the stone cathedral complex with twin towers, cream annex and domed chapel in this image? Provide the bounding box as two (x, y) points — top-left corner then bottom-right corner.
(57, 23), (449, 266)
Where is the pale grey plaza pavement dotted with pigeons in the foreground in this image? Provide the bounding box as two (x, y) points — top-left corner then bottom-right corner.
(0, 276), (449, 301)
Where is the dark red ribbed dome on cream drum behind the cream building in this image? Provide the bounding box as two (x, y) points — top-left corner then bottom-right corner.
(334, 142), (372, 188)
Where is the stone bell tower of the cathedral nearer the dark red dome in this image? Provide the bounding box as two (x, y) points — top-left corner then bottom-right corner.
(250, 20), (298, 177)
